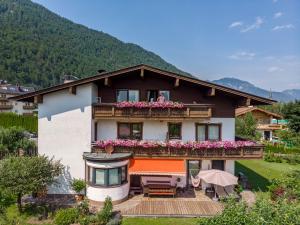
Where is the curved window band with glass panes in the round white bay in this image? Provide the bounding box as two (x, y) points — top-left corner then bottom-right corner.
(88, 166), (127, 187)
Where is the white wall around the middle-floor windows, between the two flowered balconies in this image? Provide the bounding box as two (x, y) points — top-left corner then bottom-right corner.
(97, 118), (235, 141)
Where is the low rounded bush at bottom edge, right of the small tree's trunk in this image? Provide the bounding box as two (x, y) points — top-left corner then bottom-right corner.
(54, 208), (79, 225)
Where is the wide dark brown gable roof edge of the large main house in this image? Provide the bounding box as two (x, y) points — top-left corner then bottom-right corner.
(11, 64), (276, 104)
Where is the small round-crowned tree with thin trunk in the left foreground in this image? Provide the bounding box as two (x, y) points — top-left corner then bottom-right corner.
(0, 156), (63, 212)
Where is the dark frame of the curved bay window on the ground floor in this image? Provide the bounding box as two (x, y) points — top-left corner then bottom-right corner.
(87, 165), (128, 188)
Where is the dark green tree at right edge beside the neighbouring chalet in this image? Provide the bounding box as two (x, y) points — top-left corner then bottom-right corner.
(282, 100), (300, 133)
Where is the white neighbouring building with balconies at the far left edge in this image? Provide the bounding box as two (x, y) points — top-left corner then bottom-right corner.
(0, 80), (37, 115)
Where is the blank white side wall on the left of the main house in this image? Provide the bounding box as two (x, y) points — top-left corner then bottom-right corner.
(38, 84), (96, 194)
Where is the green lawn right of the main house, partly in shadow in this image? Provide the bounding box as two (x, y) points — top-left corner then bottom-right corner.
(235, 160), (300, 191)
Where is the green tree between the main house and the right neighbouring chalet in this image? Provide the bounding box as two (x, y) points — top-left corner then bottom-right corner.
(235, 112), (259, 140)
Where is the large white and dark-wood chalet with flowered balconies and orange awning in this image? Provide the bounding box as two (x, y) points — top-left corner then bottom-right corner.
(13, 65), (274, 202)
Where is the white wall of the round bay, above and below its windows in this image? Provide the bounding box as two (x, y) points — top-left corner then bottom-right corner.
(86, 160), (130, 202)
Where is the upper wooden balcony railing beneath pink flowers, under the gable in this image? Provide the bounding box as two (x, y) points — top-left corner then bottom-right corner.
(93, 103), (212, 120)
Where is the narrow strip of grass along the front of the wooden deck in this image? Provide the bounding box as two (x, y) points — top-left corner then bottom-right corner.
(122, 218), (199, 225)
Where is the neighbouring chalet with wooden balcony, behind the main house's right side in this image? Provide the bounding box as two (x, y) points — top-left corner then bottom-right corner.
(235, 106), (286, 141)
